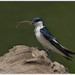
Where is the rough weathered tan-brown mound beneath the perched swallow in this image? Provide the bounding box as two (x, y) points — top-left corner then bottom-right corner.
(0, 45), (68, 74)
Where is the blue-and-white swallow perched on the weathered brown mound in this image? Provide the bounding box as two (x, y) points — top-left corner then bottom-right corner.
(32, 17), (75, 60)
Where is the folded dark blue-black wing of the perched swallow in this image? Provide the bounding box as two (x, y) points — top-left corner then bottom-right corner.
(40, 27), (71, 57)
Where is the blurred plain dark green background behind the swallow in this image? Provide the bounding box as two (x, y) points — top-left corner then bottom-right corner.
(0, 2), (75, 73)
